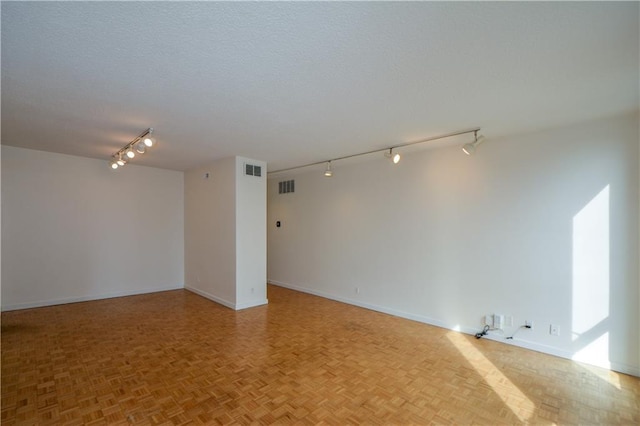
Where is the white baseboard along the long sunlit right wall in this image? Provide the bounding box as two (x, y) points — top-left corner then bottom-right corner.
(267, 280), (640, 377)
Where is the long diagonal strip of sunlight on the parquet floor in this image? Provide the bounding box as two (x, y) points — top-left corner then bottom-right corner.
(447, 332), (536, 422)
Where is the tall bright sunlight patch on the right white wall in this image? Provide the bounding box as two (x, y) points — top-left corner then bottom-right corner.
(571, 185), (610, 367)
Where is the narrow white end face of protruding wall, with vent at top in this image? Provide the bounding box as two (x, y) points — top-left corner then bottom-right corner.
(236, 157), (267, 309)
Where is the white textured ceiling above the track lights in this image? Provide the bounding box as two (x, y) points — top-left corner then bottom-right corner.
(1, 2), (640, 170)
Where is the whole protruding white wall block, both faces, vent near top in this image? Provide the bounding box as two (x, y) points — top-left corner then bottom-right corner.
(185, 157), (267, 309)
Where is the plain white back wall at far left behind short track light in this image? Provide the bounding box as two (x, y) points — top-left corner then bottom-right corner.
(2, 146), (184, 310)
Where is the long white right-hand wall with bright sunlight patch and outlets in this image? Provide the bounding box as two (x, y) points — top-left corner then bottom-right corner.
(268, 113), (640, 375)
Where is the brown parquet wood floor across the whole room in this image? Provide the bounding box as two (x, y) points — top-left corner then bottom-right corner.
(1, 286), (640, 425)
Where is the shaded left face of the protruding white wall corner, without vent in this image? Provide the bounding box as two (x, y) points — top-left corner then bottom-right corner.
(184, 157), (236, 308)
